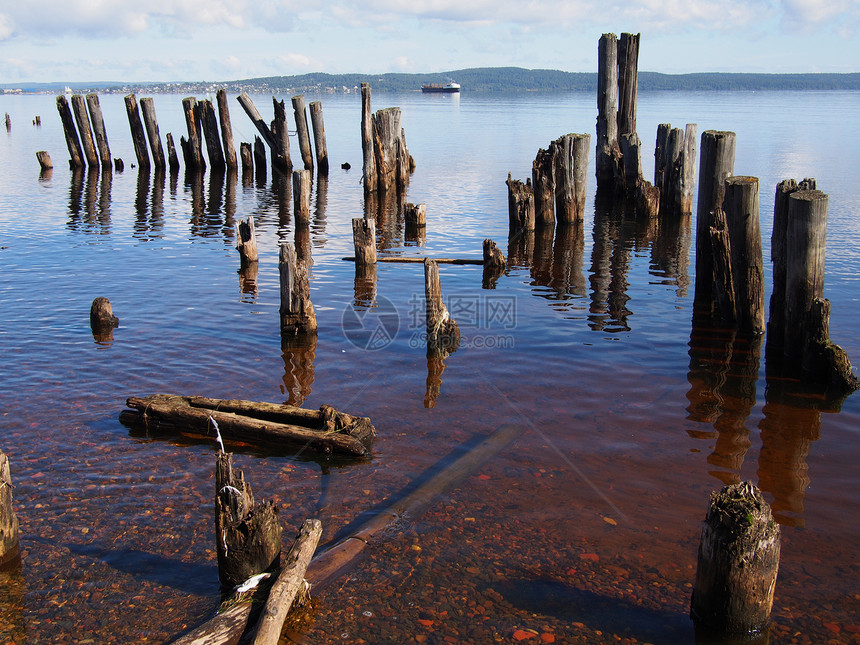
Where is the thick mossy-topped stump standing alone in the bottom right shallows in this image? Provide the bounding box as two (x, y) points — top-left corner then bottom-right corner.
(690, 482), (780, 637)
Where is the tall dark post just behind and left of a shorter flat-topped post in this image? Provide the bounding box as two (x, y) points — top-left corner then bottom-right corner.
(693, 130), (735, 316)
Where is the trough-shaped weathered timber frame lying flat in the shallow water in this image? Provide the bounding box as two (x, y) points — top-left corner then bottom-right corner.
(120, 394), (376, 456)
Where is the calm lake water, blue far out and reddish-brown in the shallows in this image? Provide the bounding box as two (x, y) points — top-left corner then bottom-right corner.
(0, 92), (860, 643)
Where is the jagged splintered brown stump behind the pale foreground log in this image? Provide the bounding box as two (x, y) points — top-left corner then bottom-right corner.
(215, 452), (281, 588)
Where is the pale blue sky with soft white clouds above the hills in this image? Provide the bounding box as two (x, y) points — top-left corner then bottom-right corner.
(0, 0), (860, 84)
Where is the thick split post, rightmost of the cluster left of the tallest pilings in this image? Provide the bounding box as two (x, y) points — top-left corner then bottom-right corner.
(552, 134), (591, 224)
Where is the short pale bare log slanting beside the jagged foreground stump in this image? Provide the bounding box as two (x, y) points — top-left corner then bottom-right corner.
(251, 520), (322, 645)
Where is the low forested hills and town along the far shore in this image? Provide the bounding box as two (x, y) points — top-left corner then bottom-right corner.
(0, 67), (860, 94)
